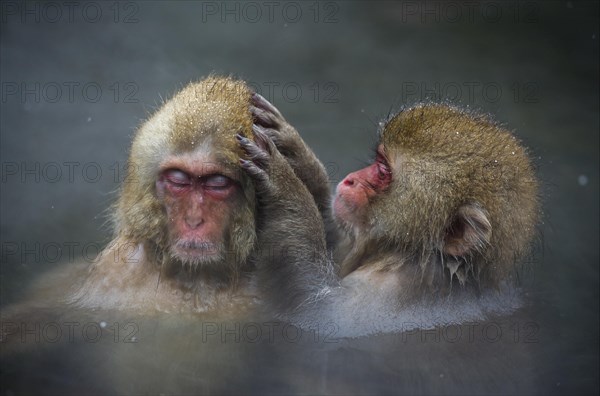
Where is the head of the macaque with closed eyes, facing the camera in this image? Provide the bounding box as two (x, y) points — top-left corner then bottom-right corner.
(116, 76), (256, 274)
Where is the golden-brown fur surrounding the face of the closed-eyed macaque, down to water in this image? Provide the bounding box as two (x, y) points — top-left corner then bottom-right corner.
(74, 76), (256, 310)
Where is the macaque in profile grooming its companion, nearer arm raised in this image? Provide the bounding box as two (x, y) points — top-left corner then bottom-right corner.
(238, 104), (538, 335)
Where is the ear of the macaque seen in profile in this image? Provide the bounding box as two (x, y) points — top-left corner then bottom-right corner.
(443, 203), (492, 257)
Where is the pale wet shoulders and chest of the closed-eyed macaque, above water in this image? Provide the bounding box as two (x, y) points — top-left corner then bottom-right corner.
(70, 244), (258, 313)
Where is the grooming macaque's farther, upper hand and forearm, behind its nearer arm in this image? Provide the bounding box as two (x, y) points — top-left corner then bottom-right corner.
(250, 93), (330, 212)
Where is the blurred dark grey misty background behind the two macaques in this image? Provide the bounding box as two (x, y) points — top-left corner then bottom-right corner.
(0, 1), (599, 394)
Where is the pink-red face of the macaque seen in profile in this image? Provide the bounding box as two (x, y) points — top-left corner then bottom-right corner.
(333, 145), (392, 227)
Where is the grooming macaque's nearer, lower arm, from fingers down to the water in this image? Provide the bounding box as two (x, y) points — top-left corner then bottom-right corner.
(237, 131), (336, 313)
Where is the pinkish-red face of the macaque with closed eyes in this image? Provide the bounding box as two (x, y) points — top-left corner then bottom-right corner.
(156, 156), (241, 264)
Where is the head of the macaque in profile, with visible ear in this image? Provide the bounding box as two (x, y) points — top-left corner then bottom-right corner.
(333, 104), (538, 284)
